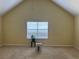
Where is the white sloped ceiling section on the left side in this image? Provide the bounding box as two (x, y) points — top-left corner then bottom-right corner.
(0, 0), (23, 16)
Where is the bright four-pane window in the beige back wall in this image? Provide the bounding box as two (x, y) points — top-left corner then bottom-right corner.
(27, 22), (48, 39)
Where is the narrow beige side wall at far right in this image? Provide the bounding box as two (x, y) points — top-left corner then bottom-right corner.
(74, 16), (79, 48)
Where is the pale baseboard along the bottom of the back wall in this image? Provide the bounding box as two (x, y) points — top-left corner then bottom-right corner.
(3, 44), (73, 47)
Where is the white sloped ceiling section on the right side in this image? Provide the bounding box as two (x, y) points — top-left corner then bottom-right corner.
(52, 0), (79, 16)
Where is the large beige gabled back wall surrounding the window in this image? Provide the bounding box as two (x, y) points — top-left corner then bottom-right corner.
(3, 0), (73, 45)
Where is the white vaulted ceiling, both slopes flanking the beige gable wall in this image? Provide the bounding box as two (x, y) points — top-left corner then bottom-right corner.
(0, 0), (79, 16)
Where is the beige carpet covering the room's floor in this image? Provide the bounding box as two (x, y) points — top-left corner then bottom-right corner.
(0, 47), (79, 59)
